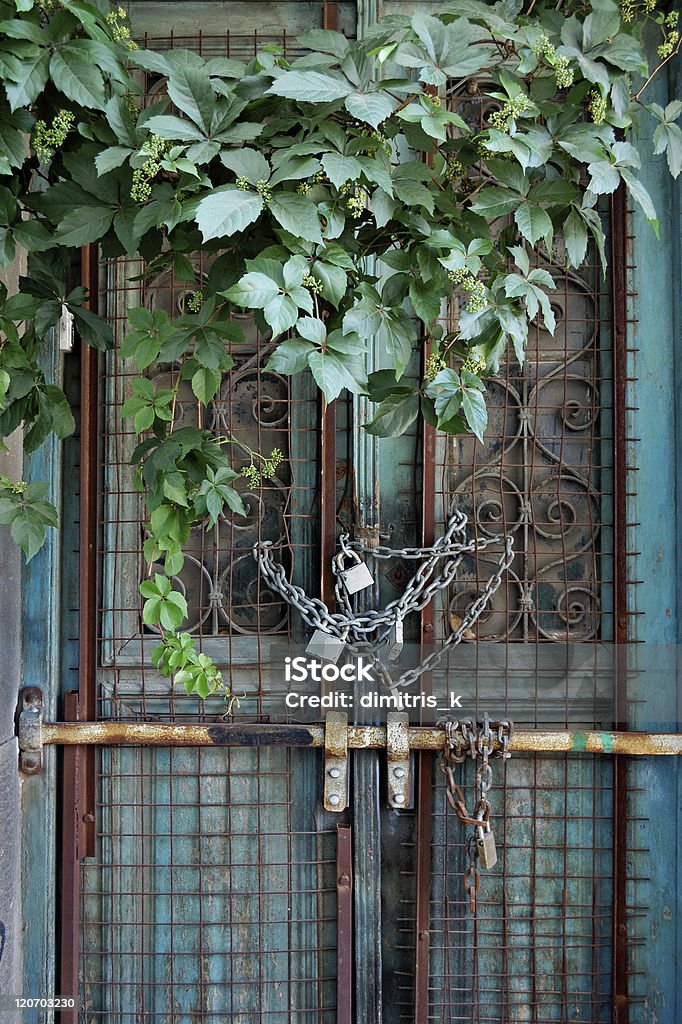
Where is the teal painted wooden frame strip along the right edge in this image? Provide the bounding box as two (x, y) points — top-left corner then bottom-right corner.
(628, 36), (682, 1024)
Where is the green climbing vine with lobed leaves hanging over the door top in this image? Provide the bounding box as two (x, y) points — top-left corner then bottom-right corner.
(0, 0), (682, 696)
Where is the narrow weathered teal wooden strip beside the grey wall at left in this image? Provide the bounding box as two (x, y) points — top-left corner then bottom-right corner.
(22, 338), (62, 1024)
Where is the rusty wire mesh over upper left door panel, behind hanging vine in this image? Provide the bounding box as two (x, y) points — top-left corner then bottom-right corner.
(100, 32), (318, 711)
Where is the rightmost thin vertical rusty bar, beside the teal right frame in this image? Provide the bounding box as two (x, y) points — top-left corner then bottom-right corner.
(610, 185), (630, 1024)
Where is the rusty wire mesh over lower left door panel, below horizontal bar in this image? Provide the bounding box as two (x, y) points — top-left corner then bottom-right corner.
(80, 749), (336, 1024)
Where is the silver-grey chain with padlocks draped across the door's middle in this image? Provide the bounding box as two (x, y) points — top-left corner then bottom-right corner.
(253, 512), (513, 689)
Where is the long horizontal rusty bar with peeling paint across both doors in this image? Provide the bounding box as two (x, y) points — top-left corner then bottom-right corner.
(31, 722), (682, 755)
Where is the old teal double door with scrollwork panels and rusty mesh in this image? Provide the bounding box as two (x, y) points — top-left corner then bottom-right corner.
(18, 2), (675, 1024)
